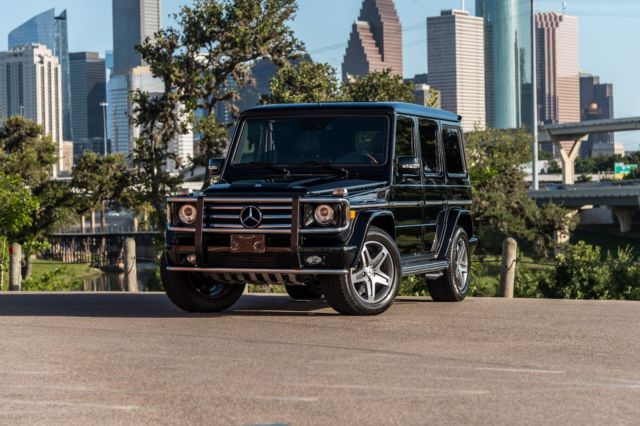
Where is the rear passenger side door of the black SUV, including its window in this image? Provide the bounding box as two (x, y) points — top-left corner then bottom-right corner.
(418, 118), (449, 252)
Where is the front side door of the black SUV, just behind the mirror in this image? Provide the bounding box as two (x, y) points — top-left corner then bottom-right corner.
(390, 115), (425, 256)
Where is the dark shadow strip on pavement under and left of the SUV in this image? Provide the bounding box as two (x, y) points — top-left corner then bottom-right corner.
(0, 293), (338, 318)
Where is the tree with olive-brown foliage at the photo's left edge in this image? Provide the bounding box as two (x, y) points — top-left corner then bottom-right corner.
(0, 116), (75, 279)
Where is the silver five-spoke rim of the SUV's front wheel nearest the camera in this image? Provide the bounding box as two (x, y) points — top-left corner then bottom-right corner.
(351, 241), (396, 303)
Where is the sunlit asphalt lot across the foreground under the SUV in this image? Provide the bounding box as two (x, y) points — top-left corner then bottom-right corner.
(0, 293), (640, 425)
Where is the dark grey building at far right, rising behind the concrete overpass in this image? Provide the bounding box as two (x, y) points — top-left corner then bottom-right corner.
(580, 73), (615, 158)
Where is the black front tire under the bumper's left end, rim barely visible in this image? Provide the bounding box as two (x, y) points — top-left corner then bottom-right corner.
(160, 256), (246, 313)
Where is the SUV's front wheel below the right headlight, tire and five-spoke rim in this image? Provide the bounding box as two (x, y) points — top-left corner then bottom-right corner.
(320, 227), (402, 315)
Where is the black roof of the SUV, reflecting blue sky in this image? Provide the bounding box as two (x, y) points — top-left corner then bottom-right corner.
(245, 102), (461, 121)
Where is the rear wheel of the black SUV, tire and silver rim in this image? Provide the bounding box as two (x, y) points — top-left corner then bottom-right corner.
(427, 226), (471, 302)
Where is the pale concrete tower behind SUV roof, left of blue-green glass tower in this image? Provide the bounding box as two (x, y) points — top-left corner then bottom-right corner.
(427, 10), (486, 132)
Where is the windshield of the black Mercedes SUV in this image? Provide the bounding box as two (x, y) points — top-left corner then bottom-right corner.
(232, 116), (388, 165)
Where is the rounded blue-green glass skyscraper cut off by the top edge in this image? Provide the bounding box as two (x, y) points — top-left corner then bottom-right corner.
(476, 0), (533, 129)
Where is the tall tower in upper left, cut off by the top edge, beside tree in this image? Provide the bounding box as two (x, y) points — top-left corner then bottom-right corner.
(112, 0), (161, 74)
